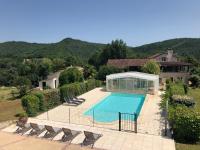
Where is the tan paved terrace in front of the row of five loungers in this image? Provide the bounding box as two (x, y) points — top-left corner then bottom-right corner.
(0, 131), (100, 150)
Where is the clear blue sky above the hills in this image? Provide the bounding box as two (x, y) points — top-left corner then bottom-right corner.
(0, 0), (200, 46)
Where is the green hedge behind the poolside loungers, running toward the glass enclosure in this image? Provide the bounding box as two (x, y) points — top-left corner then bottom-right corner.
(60, 79), (101, 102)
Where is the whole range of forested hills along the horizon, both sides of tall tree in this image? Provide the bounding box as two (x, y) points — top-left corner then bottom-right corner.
(0, 38), (200, 60)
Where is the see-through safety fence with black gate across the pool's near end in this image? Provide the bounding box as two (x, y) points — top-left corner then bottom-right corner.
(36, 107), (138, 132)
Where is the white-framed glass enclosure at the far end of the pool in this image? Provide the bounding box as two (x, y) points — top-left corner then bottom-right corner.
(106, 72), (159, 94)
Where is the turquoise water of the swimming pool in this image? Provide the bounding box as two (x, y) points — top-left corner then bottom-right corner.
(84, 93), (145, 122)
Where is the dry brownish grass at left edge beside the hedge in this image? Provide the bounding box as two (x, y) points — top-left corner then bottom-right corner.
(0, 87), (23, 122)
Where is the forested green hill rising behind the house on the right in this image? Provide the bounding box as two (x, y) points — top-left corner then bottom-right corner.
(129, 38), (200, 59)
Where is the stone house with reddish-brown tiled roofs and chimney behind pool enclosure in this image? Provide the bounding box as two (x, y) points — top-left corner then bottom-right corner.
(107, 50), (192, 84)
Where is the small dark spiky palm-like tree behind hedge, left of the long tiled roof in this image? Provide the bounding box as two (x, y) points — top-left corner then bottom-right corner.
(83, 65), (97, 79)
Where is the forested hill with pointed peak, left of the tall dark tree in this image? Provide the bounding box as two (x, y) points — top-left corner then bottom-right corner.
(0, 38), (103, 59)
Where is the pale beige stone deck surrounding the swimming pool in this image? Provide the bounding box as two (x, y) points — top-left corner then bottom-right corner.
(3, 88), (175, 150)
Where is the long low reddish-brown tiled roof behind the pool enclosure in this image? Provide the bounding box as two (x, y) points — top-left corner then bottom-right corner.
(107, 59), (150, 68)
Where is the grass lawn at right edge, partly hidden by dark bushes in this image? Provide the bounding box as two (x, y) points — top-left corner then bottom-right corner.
(176, 88), (200, 150)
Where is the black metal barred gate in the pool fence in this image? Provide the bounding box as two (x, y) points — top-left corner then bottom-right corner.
(119, 112), (137, 133)
